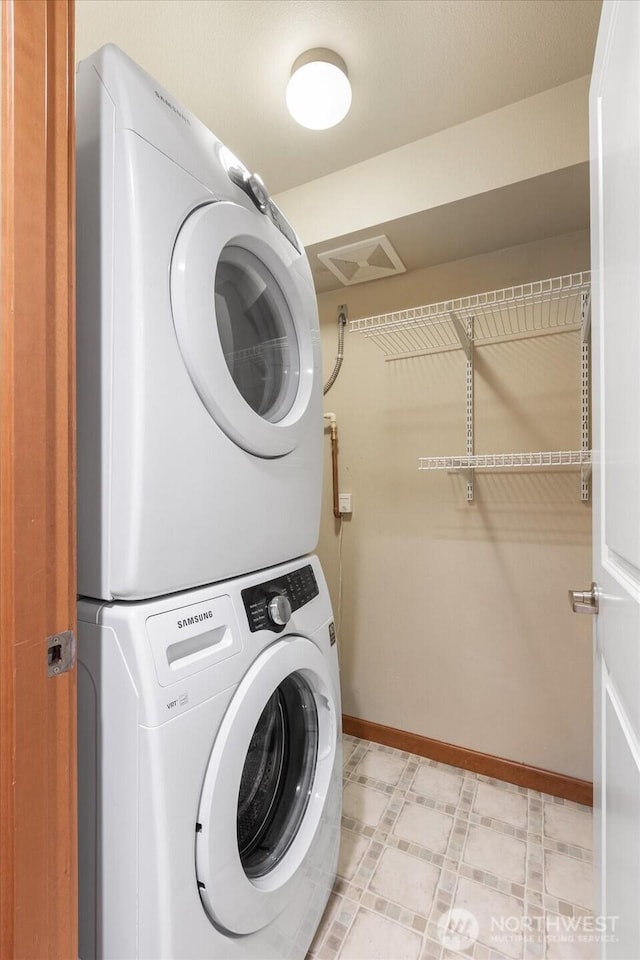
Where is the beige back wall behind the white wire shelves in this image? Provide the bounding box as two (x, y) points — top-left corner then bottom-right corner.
(319, 232), (591, 779)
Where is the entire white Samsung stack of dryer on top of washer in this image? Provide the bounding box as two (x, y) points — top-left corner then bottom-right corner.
(77, 45), (342, 960)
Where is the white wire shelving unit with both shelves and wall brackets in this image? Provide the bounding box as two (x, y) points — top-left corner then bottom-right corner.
(350, 271), (591, 501)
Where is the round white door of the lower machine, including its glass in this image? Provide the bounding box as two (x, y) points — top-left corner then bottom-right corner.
(196, 636), (338, 934)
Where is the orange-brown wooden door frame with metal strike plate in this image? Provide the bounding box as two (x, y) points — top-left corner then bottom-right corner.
(0, 0), (78, 960)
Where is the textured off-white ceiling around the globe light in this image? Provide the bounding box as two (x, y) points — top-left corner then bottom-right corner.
(76, 0), (601, 193)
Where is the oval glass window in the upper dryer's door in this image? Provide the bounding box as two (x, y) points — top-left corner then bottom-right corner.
(215, 246), (300, 423)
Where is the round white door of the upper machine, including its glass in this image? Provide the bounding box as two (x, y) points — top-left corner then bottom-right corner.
(171, 202), (319, 457)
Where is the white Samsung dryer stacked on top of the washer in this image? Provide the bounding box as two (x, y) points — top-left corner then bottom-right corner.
(77, 45), (322, 600)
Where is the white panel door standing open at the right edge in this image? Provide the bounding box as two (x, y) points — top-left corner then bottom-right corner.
(590, 0), (640, 960)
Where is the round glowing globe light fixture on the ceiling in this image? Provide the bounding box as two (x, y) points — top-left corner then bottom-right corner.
(287, 47), (351, 130)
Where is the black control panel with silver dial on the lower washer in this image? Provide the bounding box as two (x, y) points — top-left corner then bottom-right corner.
(242, 564), (320, 633)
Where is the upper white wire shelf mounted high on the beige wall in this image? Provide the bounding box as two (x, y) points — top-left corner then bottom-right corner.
(349, 271), (591, 360)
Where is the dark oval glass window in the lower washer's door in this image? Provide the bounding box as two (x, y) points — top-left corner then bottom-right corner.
(237, 673), (318, 879)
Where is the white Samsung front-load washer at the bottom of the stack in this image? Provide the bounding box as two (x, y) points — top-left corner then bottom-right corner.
(78, 557), (342, 960)
